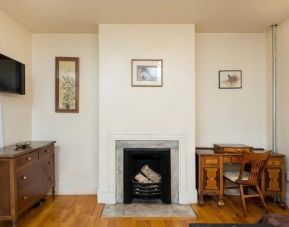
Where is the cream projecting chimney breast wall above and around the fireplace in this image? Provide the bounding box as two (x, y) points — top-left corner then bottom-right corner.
(98, 25), (196, 203)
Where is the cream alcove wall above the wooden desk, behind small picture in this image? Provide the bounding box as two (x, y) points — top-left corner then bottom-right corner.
(196, 33), (268, 148)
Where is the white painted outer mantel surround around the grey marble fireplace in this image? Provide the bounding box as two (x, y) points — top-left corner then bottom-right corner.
(97, 133), (197, 204)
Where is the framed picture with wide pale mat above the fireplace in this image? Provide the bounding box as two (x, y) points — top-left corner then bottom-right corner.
(131, 59), (163, 87)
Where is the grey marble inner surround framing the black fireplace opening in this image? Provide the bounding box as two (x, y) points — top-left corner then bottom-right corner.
(115, 140), (179, 203)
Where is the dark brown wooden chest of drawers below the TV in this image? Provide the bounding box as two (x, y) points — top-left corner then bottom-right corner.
(0, 141), (55, 224)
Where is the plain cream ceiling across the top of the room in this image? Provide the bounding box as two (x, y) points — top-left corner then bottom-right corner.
(0, 0), (289, 33)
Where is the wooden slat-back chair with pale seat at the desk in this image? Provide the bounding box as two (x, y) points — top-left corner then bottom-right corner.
(224, 151), (271, 216)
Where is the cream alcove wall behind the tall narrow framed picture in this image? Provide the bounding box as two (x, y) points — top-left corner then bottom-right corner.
(32, 34), (98, 194)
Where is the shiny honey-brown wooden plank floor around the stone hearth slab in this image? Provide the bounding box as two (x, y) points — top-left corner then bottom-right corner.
(0, 195), (289, 227)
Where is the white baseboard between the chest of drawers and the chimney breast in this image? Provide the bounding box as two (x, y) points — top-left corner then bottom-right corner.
(55, 181), (97, 195)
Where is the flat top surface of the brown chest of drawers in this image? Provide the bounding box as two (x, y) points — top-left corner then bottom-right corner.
(0, 141), (55, 159)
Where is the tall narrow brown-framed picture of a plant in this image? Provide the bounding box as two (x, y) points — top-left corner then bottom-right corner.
(55, 57), (79, 113)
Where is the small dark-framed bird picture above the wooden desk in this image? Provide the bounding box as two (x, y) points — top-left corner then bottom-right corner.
(219, 70), (242, 89)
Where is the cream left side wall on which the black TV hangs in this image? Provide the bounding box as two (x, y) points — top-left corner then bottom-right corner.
(0, 10), (32, 145)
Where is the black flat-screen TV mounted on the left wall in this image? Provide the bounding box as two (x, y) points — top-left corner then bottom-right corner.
(0, 54), (25, 95)
